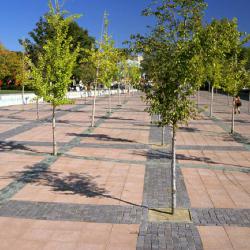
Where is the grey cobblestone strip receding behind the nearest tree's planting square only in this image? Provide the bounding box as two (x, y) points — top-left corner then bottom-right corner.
(143, 126), (190, 208)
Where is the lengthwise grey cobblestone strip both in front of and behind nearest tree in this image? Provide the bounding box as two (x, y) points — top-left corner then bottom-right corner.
(136, 121), (195, 250)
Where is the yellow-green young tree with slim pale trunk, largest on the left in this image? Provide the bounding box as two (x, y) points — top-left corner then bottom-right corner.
(28, 0), (79, 155)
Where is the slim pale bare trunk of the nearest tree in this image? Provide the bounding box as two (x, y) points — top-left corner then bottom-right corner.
(171, 125), (176, 214)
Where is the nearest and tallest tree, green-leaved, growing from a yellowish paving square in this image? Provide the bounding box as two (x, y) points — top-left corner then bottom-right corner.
(133, 0), (205, 214)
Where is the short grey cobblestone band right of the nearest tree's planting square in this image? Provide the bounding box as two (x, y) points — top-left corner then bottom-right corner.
(190, 208), (250, 227)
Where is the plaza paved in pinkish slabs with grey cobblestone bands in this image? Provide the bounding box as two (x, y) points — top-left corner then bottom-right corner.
(0, 92), (250, 250)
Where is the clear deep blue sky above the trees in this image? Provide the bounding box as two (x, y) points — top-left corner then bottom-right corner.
(0, 0), (250, 50)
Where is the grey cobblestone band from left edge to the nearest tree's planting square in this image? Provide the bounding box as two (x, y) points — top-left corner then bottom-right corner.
(0, 200), (147, 224)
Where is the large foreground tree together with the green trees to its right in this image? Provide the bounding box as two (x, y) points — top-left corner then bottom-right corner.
(132, 0), (250, 213)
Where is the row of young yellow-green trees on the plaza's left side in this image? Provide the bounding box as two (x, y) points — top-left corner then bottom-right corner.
(23, 0), (140, 155)
